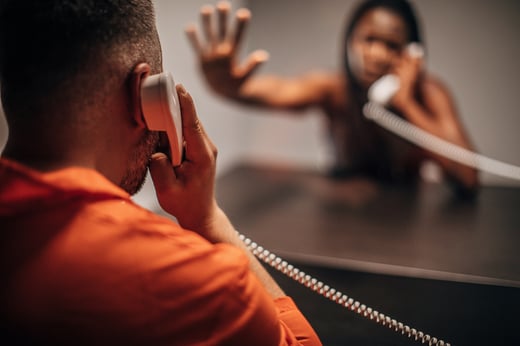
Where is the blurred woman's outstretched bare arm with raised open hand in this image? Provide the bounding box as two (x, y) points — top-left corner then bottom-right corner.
(186, 2), (334, 110)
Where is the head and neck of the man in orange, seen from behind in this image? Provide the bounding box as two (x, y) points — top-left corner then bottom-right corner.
(0, 0), (162, 193)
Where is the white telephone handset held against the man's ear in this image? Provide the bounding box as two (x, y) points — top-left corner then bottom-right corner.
(141, 72), (184, 166)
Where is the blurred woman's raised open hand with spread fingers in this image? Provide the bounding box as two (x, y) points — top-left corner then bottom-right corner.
(186, 1), (268, 98)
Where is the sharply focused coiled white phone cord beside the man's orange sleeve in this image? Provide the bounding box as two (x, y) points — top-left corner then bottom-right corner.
(238, 233), (450, 346)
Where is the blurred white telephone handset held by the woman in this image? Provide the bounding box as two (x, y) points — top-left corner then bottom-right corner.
(368, 42), (424, 106)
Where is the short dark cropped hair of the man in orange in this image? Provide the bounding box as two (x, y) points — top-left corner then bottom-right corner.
(0, 0), (161, 121)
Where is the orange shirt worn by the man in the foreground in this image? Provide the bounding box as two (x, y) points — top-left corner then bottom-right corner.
(0, 159), (320, 346)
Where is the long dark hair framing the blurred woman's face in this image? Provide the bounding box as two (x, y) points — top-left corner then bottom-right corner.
(342, 0), (423, 90)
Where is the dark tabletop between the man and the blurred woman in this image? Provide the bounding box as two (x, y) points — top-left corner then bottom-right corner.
(217, 164), (520, 287)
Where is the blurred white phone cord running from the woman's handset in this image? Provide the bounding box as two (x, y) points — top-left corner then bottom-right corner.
(363, 102), (520, 180)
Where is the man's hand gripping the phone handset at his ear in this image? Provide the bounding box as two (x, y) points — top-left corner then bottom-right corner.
(150, 85), (220, 236)
